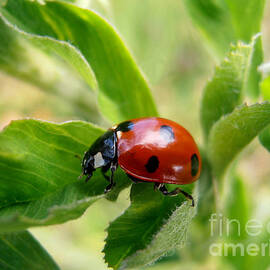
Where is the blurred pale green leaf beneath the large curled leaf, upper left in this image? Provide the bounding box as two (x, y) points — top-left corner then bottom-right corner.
(0, 13), (98, 121)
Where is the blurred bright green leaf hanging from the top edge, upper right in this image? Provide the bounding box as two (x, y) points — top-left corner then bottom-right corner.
(184, 0), (265, 58)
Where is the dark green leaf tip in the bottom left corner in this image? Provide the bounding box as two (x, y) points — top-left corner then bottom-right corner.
(0, 231), (59, 270)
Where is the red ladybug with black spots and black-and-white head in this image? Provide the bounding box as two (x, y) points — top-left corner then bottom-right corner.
(80, 117), (201, 206)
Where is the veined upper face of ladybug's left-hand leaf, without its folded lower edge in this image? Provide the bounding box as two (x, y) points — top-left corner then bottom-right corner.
(0, 119), (104, 207)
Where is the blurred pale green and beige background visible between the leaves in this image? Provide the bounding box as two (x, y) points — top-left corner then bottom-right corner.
(0, 0), (270, 270)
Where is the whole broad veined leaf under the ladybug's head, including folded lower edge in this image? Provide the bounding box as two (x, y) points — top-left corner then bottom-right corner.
(0, 119), (129, 232)
